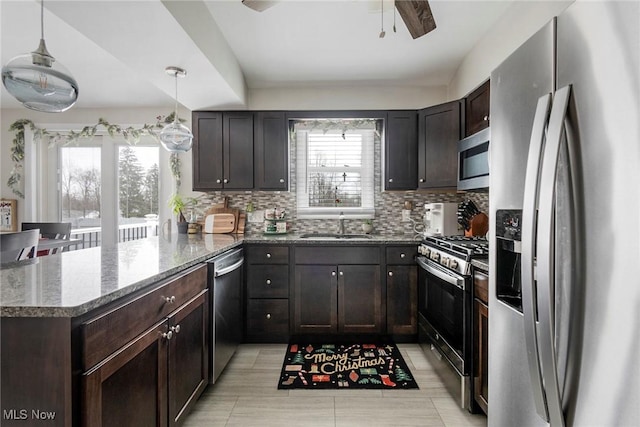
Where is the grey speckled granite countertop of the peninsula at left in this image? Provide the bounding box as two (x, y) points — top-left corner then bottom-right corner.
(0, 234), (243, 317)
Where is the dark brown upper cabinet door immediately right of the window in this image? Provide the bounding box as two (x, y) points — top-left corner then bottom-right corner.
(384, 110), (418, 190)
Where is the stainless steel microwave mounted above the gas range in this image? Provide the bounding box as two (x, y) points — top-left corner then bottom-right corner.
(458, 128), (491, 190)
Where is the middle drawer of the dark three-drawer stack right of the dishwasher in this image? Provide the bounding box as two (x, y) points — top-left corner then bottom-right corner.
(247, 265), (289, 298)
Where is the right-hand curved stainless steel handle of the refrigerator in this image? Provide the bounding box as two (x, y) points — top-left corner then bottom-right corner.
(536, 86), (571, 427)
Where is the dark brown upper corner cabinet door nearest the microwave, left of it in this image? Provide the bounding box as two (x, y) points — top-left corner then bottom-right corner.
(418, 101), (461, 189)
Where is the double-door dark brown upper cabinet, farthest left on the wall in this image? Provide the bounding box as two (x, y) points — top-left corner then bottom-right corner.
(192, 111), (254, 191)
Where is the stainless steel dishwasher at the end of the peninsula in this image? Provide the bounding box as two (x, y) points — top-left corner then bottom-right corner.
(209, 248), (244, 384)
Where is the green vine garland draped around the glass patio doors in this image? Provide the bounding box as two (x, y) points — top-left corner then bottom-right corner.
(7, 113), (184, 199)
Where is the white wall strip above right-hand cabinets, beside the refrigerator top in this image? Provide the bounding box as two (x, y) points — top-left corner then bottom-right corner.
(448, 0), (573, 100)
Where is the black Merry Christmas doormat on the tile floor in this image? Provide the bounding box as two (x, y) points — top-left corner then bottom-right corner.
(278, 344), (418, 390)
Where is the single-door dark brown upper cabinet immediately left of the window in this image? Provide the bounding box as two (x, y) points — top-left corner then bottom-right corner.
(254, 111), (289, 191)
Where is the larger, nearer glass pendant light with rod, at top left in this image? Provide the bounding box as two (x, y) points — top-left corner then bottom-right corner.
(2, 0), (78, 113)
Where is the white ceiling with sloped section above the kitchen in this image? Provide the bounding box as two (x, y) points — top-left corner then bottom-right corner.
(0, 0), (513, 110)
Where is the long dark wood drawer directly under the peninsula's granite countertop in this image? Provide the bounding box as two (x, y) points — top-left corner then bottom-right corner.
(81, 265), (207, 371)
